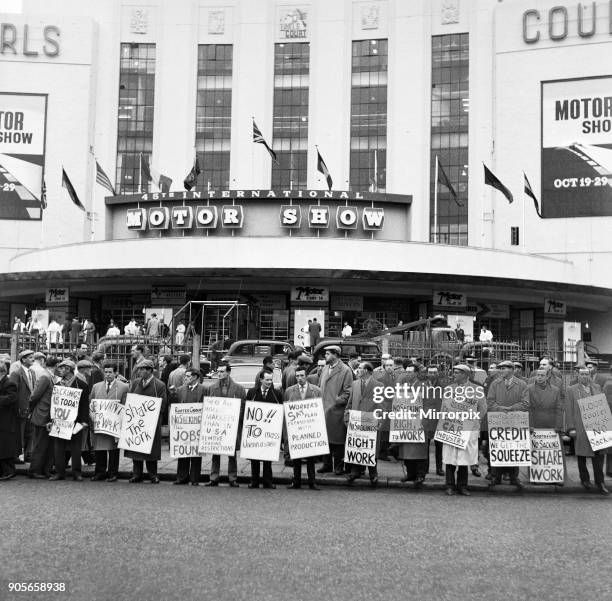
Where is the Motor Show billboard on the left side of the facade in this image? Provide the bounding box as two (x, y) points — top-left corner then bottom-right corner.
(0, 92), (47, 220)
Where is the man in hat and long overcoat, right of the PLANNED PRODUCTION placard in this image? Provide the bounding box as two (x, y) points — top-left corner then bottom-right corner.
(317, 345), (353, 476)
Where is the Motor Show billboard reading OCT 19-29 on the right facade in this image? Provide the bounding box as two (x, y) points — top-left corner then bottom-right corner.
(541, 75), (612, 217)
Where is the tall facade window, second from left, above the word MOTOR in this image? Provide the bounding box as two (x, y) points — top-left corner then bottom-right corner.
(196, 44), (233, 190)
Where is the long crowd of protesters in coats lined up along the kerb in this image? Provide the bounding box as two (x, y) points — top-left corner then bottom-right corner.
(0, 345), (612, 496)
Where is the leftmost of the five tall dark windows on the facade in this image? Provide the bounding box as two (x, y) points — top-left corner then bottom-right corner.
(115, 44), (155, 194)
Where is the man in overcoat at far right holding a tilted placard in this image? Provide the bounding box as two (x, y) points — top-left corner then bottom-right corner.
(565, 367), (612, 495)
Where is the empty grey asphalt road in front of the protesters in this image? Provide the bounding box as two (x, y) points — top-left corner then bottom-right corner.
(0, 478), (612, 601)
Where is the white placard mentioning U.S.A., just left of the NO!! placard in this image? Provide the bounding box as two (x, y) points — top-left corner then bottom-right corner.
(199, 397), (242, 456)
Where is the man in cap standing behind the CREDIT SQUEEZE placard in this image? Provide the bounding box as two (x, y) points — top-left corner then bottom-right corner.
(487, 361), (529, 491)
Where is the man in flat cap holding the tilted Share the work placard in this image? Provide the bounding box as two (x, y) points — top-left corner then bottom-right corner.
(125, 359), (168, 484)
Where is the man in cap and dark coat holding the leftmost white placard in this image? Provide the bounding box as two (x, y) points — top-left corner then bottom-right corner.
(49, 359), (89, 482)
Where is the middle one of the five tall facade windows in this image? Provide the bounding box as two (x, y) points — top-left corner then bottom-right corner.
(272, 43), (310, 190)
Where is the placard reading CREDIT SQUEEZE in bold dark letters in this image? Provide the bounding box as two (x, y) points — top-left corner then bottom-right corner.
(487, 411), (531, 467)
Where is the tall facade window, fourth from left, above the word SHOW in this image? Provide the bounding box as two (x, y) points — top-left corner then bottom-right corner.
(350, 40), (388, 192)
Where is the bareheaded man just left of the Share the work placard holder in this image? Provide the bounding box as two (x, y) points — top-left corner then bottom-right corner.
(90, 362), (129, 482)
